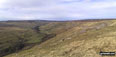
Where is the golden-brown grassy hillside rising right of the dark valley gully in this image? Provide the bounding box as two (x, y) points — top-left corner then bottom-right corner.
(1, 20), (116, 57)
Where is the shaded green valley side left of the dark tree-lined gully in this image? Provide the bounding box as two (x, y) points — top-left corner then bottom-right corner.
(0, 22), (48, 57)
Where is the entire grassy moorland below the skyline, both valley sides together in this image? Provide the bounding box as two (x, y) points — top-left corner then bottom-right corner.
(0, 20), (116, 57)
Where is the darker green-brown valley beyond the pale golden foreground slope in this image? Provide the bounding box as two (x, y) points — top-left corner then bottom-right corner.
(0, 21), (81, 57)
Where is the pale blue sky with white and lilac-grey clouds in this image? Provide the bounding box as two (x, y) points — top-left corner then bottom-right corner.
(0, 0), (116, 20)
